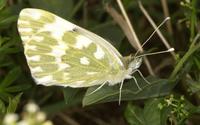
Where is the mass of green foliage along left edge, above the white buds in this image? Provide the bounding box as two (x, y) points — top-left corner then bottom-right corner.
(0, 0), (30, 114)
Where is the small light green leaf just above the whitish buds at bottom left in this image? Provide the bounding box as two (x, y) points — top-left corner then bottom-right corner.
(7, 93), (22, 113)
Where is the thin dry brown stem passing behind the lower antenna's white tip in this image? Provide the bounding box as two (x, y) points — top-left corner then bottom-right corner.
(138, 1), (176, 59)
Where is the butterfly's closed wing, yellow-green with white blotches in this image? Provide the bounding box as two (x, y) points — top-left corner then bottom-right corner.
(18, 8), (124, 87)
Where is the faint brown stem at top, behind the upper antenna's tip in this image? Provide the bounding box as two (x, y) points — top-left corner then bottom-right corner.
(161, 0), (173, 35)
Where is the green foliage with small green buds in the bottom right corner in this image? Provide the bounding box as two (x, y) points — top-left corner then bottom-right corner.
(125, 95), (200, 125)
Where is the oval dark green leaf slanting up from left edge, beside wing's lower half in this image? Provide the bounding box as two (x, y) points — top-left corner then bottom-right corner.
(0, 67), (21, 88)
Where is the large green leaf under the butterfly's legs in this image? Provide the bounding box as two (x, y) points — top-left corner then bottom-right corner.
(82, 77), (174, 106)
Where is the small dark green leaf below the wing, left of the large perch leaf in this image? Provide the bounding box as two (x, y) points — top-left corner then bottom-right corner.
(63, 87), (85, 105)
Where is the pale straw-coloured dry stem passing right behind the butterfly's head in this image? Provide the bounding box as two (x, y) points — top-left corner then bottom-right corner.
(114, 0), (155, 75)
